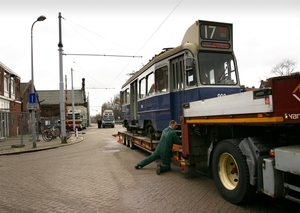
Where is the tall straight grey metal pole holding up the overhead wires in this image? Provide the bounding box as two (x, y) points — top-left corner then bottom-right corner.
(58, 12), (67, 143)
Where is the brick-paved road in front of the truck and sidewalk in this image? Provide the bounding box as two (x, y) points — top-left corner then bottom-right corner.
(0, 125), (300, 213)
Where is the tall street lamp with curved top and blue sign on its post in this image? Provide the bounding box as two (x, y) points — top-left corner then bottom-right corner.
(31, 16), (46, 148)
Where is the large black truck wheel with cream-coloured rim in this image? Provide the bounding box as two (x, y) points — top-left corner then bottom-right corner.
(212, 139), (254, 204)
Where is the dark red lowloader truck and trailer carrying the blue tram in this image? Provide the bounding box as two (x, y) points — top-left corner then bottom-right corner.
(118, 74), (300, 204)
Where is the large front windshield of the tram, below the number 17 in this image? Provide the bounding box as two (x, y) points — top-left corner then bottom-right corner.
(198, 52), (237, 85)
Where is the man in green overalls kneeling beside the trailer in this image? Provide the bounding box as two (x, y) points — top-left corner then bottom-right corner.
(135, 120), (182, 175)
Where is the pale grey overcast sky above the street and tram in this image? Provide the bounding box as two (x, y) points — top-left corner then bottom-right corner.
(0, 0), (300, 114)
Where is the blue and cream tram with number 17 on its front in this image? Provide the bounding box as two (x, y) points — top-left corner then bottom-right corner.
(120, 20), (240, 137)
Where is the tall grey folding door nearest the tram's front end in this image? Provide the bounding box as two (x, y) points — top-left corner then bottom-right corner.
(170, 55), (185, 123)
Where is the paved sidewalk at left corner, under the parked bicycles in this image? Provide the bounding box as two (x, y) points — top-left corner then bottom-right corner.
(0, 134), (84, 155)
